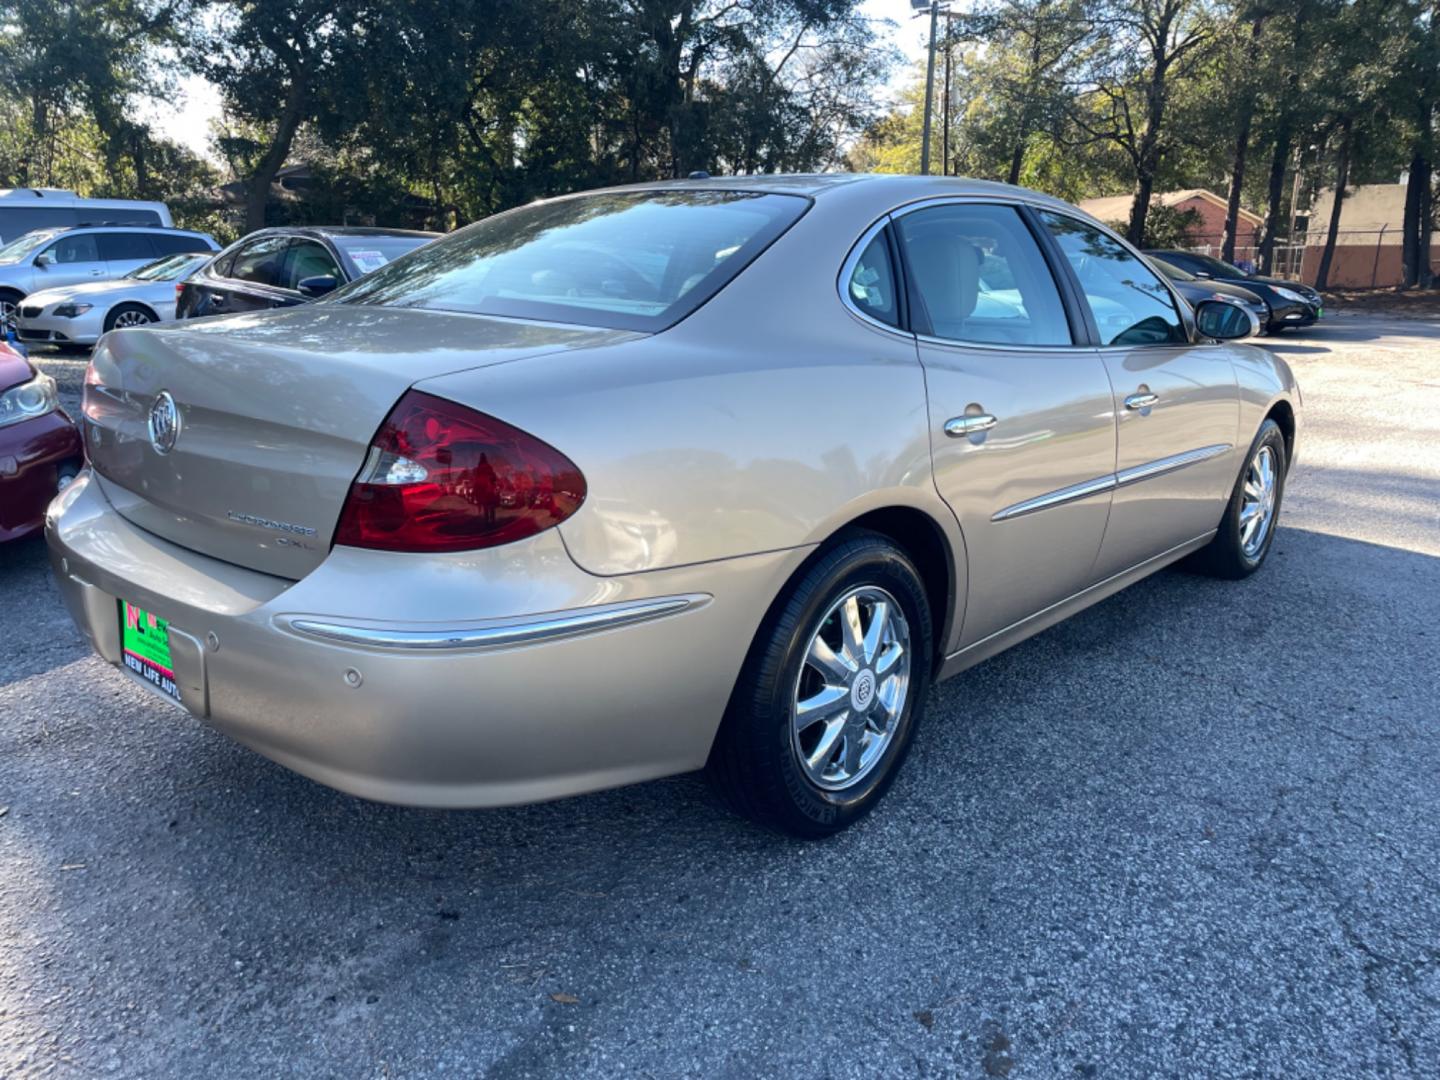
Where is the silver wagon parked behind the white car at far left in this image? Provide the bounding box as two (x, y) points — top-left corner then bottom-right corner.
(0, 225), (220, 324)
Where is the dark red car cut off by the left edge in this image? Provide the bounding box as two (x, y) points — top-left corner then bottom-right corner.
(0, 341), (84, 543)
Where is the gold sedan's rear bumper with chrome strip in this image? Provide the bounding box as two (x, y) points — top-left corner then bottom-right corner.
(46, 474), (805, 806)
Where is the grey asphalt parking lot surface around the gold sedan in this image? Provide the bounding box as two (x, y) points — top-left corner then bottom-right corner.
(0, 317), (1440, 1079)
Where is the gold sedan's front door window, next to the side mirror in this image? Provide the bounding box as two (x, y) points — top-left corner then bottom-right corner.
(1040, 210), (1188, 346)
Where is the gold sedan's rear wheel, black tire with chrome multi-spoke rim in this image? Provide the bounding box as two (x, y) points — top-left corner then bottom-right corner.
(707, 531), (933, 838)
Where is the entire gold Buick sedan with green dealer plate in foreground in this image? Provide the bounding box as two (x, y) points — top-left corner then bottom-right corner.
(48, 176), (1300, 837)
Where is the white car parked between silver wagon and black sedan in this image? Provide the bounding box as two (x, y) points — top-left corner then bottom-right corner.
(16, 252), (213, 346)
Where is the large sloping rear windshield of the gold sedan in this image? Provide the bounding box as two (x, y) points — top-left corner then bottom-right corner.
(336, 192), (809, 330)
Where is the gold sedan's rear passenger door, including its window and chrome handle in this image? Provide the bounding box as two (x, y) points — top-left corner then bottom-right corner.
(894, 200), (1115, 648)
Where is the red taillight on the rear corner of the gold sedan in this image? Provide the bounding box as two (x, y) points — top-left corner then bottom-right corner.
(336, 390), (585, 552)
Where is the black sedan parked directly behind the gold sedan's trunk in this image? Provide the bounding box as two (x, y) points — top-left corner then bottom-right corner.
(176, 226), (441, 318)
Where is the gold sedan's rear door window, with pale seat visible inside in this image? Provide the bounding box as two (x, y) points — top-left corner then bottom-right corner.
(897, 203), (1071, 346)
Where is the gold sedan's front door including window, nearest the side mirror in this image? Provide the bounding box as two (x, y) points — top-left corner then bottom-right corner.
(1040, 210), (1240, 577)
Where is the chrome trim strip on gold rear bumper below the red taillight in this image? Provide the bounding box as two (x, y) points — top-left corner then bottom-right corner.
(276, 593), (710, 651)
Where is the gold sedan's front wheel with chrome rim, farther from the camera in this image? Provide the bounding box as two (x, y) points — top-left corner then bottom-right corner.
(1189, 419), (1289, 580)
